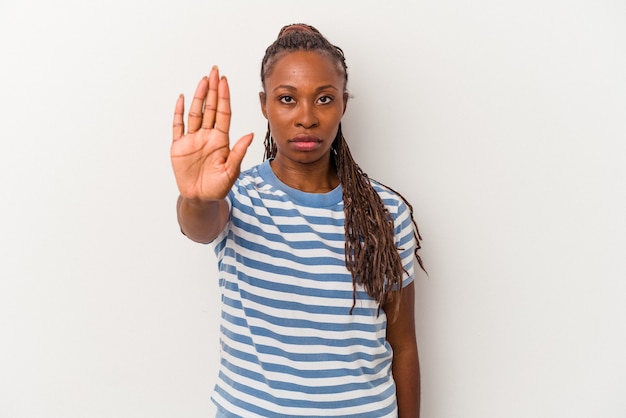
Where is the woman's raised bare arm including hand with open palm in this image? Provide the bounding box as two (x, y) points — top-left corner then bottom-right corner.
(170, 67), (252, 243)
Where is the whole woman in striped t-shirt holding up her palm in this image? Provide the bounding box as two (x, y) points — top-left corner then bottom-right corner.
(171, 24), (421, 418)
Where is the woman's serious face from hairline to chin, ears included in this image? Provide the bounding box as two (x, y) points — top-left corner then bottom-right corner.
(260, 51), (347, 165)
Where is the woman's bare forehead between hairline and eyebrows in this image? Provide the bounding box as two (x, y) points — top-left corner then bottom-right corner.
(265, 51), (344, 90)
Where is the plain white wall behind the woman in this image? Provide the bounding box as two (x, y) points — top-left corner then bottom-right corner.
(0, 0), (626, 418)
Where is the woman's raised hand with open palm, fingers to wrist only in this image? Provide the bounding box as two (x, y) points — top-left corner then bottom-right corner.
(170, 67), (253, 201)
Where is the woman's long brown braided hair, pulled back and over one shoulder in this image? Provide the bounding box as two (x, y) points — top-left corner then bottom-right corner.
(261, 23), (424, 317)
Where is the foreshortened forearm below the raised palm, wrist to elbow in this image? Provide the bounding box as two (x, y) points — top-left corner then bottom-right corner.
(176, 196), (228, 243)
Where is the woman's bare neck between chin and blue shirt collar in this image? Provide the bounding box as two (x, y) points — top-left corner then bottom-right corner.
(270, 154), (339, 193)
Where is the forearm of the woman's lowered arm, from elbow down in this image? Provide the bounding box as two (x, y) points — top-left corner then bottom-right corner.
(392, 348), (421, 418)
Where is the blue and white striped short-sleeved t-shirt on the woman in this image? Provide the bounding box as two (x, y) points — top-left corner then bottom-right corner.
(212, 161), (415, 418)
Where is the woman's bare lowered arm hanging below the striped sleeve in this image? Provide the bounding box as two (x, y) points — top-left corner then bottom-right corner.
(387, 283), (420, 418)
